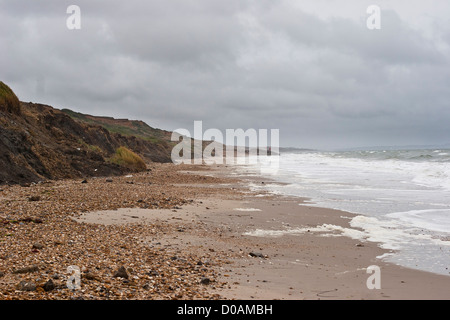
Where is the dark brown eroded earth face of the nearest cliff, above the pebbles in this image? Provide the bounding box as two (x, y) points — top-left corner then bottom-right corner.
(0, 102), (171, 184)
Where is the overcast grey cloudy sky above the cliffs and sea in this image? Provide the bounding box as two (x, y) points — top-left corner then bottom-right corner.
(0, 0), (450, 149)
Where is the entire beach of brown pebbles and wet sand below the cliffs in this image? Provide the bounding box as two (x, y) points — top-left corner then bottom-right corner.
(0, 164), (450, 300)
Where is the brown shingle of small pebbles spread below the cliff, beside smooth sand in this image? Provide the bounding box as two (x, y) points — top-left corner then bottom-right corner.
(0, 164), (232, 300)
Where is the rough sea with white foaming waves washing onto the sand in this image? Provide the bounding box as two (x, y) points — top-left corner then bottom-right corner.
(236, 148), (450, 276)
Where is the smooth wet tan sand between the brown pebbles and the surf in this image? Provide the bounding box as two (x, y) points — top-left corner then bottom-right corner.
(82, 167), (450, 300)
